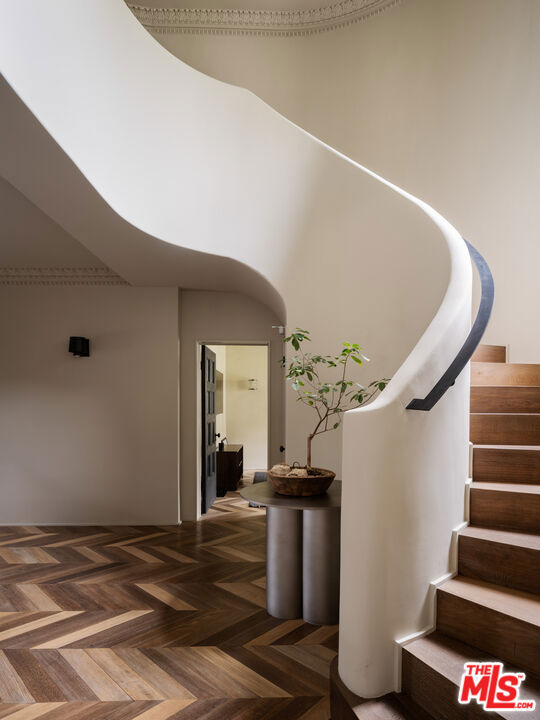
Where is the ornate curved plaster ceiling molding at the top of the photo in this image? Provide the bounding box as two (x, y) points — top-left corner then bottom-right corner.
(128, 0), (403, 37)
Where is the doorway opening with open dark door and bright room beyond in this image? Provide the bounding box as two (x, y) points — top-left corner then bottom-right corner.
(200, 343), (270, 513)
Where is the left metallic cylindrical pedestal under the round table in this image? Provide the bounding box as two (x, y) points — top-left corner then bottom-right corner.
(266, 507), (302, 620)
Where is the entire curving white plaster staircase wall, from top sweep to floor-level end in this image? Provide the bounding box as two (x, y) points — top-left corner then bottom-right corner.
(0, 0), (471, 696)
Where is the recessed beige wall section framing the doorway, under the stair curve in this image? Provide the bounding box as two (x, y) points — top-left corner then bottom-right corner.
(180, 290), (285, 520)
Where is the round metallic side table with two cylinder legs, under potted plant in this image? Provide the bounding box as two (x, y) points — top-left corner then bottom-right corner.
(240, 480), (341, 625)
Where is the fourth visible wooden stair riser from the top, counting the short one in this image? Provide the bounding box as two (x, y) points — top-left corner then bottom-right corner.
(470, 414), (540, 445)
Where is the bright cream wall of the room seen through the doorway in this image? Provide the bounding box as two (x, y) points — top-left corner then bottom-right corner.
(225, 345), (268, 470)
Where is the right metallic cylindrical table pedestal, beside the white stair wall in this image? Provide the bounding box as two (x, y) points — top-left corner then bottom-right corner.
(302, 508), (341, 625)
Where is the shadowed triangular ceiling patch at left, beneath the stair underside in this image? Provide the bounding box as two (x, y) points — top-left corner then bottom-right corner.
(0, 178), (105, 268)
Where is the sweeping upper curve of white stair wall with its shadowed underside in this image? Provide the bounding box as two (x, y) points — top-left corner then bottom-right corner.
(2, 0), (460, 480)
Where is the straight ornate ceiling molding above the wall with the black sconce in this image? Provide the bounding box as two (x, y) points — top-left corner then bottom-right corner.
(0, 267), (129, 285)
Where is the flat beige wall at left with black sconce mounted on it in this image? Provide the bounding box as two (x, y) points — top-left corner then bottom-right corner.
(0, 287), (178, 524)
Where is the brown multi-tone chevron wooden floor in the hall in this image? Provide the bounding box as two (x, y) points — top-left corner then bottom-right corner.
(0, 493), (337, 720)
